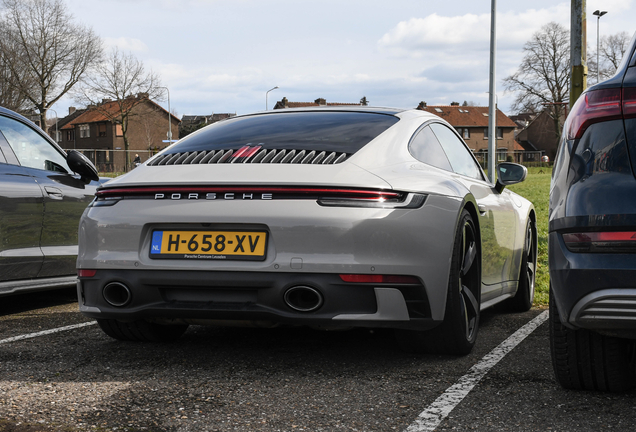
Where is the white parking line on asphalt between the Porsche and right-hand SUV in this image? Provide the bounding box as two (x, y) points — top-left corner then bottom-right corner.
(406, 311), (548, 432)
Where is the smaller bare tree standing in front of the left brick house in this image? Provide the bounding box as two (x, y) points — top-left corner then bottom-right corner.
(78, 48), (163, 171)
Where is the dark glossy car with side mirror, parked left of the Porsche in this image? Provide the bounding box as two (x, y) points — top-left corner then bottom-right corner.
(0, 107), (100, 296)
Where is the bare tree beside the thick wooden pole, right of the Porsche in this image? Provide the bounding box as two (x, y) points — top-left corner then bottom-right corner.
(504, 22), (570, 139)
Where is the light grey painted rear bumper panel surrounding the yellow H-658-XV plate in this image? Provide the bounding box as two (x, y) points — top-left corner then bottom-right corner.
(77, 195), (462, 321)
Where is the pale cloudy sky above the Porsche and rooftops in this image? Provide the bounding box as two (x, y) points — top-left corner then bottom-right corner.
(54, 0), (636, 117)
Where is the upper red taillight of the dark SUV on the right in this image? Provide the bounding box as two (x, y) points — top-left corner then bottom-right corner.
(567, 88), (620, 140)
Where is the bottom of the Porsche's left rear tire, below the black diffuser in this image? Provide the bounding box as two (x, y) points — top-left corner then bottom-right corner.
(97, 319), (188, 342)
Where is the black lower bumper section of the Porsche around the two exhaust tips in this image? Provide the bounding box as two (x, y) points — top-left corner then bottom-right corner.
(78, 270), (439, 330)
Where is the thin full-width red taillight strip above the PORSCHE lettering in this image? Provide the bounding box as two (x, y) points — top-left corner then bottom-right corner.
(95, 186), (402, 199)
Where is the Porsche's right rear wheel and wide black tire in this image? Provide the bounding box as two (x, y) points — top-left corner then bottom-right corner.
(396, 210), (481, 355)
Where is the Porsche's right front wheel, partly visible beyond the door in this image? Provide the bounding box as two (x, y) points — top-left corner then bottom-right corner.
(507, 220), (537, 312)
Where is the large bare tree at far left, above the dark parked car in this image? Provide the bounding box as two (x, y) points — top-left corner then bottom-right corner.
(0, 0), (102, 128)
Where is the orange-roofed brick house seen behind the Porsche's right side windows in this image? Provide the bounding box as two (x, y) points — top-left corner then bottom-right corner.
(417, 102), (523, 162)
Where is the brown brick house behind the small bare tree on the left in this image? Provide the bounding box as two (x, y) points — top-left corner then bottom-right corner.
(56, 95), (180, 171)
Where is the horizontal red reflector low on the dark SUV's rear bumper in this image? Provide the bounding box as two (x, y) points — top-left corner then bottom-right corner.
(563, 231), (636, 253)
